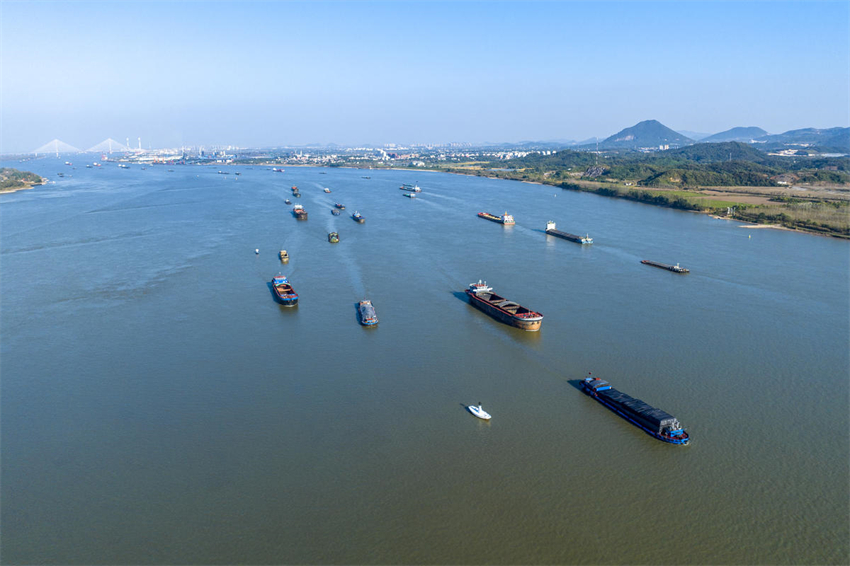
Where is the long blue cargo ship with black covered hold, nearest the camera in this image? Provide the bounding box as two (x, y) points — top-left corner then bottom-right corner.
(581, 377), (690, 444)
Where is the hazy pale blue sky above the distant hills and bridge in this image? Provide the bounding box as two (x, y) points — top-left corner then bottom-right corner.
(0, 0), (850, 153)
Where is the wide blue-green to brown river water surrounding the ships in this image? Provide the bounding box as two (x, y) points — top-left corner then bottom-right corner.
(0, 157), (850, 564)
